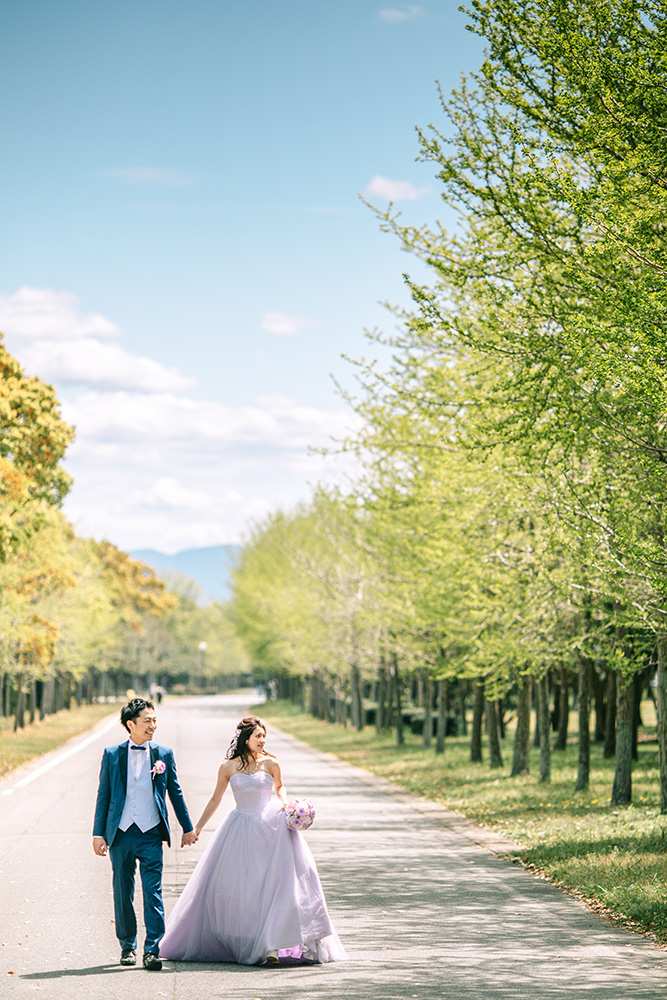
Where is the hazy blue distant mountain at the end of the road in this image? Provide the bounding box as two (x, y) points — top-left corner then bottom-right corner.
(130, 545), (241, 604)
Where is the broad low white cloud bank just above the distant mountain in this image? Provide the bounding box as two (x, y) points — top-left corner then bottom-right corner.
(64, 393), (357, 552)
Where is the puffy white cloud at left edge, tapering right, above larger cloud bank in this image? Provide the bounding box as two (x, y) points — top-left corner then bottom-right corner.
(0, 287), (197, 392)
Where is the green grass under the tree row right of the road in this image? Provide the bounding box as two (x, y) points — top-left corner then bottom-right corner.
(256, 701), (667, 943)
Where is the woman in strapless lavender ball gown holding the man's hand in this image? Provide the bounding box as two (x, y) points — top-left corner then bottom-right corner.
(160, 715), (347, 965)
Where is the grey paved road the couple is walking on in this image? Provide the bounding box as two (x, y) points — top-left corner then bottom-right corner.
(0, 696), (667, 1000)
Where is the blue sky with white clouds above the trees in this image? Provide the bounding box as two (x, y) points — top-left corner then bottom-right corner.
(0, 0), (481, 552)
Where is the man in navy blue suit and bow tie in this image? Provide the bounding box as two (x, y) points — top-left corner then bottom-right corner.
(93, 698), (197, 972)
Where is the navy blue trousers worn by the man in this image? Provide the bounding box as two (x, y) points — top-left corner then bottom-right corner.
(109, 823), (164, 954)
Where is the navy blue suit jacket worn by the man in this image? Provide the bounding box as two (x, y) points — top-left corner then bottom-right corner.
(93, 742), (194, 847)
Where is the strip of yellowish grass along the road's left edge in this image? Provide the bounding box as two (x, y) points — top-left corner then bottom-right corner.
(0, 704), (120, 778)
